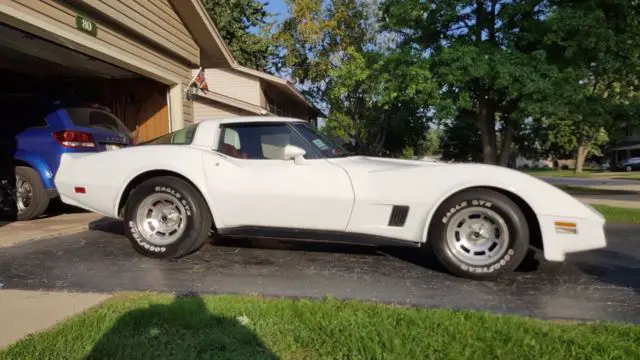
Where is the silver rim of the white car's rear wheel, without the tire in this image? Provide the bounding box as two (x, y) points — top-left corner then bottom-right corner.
(136, 194), (187, 246)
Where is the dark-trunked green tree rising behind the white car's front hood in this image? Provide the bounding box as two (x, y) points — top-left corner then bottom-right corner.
(383, 0), (554, 165)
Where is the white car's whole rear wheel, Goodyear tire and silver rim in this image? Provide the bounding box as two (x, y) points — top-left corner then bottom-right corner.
(124, 176), (212, 259)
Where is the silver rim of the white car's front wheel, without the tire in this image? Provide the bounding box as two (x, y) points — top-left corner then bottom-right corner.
(447, 207), (509, 266)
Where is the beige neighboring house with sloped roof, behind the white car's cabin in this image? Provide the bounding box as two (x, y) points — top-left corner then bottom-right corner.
(192, 67), (324, 126)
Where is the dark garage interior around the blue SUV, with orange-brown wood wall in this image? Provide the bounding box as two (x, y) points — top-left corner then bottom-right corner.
(0, 24), (175, 221)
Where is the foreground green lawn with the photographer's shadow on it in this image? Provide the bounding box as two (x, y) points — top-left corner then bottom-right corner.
(0, 294), (640, 360)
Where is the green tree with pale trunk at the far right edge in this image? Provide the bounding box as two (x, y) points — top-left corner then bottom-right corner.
(538, 0), (640, 172)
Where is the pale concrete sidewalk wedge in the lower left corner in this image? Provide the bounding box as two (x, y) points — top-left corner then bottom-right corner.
(0, 289), (110, 348)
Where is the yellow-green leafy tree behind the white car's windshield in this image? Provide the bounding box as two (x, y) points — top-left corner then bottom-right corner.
(276, 0), (436, 156)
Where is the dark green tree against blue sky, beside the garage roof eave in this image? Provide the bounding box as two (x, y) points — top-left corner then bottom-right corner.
(203, 0), (277, 71)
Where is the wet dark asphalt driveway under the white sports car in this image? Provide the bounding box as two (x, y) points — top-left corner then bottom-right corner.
(0, 226), (640, 323)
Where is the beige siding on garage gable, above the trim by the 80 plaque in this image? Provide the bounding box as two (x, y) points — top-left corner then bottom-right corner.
(78, 0), (200, 64)
